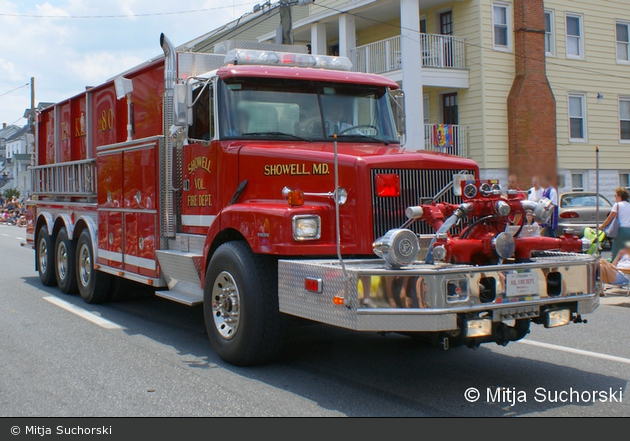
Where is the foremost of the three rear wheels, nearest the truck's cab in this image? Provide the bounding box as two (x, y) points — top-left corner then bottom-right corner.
(75, 229), (112, 303)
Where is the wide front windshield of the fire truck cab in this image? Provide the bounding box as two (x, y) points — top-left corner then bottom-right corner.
(219, 78), (398, 143)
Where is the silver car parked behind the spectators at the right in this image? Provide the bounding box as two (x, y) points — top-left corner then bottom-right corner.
(556, 191), (612, 237)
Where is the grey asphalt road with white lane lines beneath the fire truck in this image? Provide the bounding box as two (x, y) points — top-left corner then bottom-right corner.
(0, 225), (630, 417)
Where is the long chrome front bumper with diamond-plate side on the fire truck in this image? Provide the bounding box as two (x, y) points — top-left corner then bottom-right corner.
(278, 253), (600, 332)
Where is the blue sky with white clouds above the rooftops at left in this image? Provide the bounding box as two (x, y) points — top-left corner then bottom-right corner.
(0, 0), (256, 124)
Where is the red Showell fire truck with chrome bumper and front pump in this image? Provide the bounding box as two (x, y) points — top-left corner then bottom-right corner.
(29, 35), (599, 365)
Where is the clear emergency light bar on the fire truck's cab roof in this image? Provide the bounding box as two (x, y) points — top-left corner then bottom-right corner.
(225, 49), (352, 71)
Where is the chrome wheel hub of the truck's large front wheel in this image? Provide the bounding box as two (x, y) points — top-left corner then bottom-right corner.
(212, 271), (241, 340)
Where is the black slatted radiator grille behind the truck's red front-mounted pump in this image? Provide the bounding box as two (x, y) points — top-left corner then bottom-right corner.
(371, 168), (474, 240)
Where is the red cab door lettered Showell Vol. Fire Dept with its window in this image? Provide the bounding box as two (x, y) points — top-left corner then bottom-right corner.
(181, 81), (218, 234)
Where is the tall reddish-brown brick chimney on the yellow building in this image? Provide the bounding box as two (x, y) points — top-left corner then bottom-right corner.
(507, 0), (557, 190)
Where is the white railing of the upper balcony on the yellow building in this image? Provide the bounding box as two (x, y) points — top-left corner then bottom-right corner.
(351, 34), (466, 74)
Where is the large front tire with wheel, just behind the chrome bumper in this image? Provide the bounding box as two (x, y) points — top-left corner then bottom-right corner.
(203, 242), (286, 366)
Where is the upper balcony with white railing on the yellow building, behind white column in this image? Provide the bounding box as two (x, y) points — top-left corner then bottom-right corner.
(351, 34), (468, 88)
